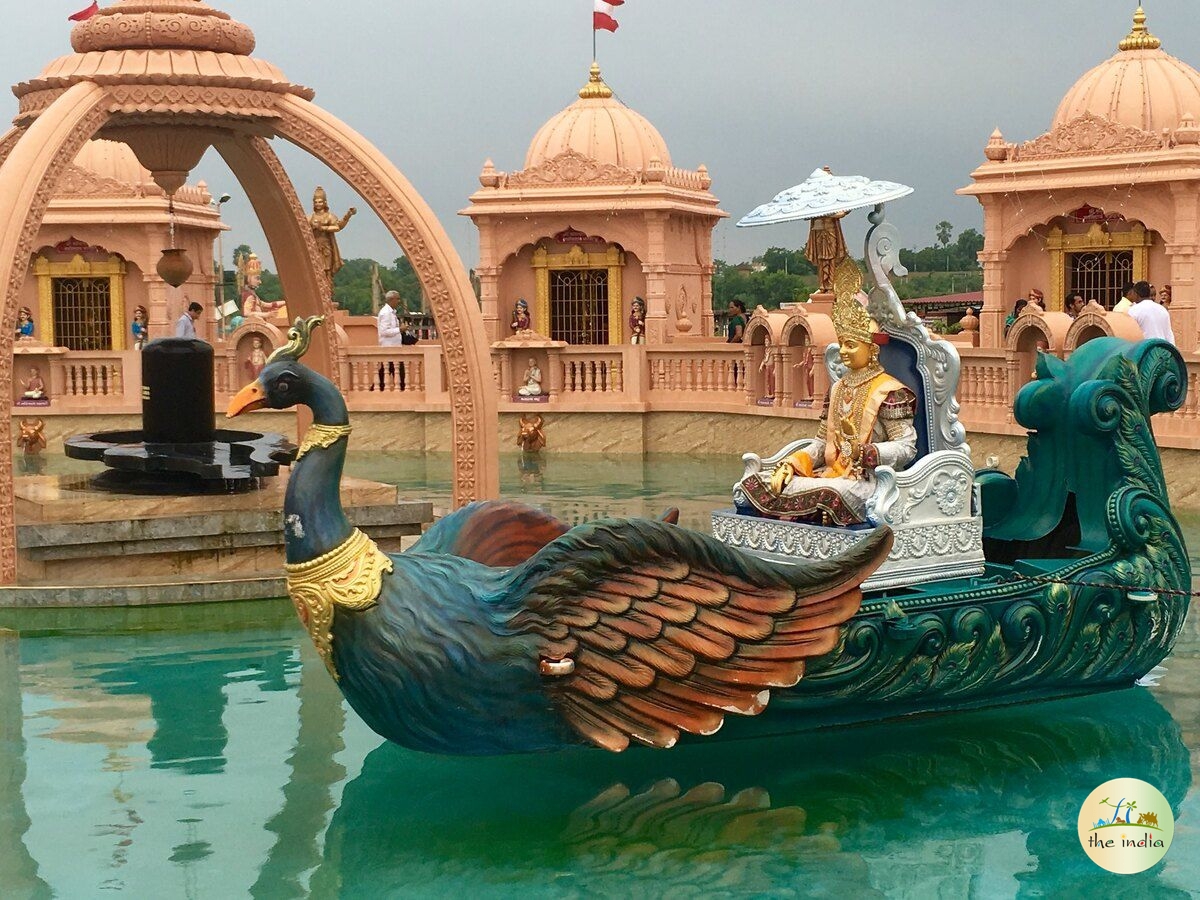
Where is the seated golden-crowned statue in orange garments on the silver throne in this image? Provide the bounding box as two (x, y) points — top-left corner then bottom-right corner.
(740, 260), (917, 526)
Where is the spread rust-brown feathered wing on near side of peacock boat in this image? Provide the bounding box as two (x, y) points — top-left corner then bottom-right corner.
(509, 520), (892, 751)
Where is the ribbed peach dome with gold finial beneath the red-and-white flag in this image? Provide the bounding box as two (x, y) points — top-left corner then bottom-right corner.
(524, 62), (676, 172)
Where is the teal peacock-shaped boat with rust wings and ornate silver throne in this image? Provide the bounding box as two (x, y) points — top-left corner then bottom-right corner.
(229, 205), (1190, 755)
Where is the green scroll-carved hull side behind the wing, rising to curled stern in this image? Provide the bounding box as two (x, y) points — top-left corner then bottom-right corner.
(788, 504), (1187, 708)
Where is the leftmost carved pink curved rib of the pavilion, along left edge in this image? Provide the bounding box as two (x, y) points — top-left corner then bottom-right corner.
(0, 83), (110, 584)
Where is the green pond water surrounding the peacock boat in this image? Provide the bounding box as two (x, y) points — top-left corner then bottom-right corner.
(0, 455), (1200, 900)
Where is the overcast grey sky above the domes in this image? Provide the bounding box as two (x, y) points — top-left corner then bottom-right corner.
(0, 0), (1200, 266)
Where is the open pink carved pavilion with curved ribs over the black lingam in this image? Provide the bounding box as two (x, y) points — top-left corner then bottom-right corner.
(0, 0), (499, 583)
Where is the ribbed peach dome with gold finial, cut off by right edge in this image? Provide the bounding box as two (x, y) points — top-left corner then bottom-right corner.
(1051, 7), (1200, 133)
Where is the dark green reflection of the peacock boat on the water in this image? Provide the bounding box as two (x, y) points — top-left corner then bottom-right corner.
(313, 689), (1190, 896)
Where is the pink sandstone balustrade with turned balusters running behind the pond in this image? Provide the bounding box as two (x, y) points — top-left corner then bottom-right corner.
(22, 342), (1200, 449)
